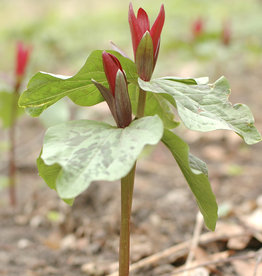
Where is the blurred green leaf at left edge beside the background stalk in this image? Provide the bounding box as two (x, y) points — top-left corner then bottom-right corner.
(0, 91), (24, 128)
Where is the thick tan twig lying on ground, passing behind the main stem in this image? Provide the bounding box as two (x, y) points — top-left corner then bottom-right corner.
(109, 230), (247, 276)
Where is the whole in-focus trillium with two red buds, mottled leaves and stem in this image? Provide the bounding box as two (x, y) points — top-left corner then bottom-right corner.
(19, 4), (261, 276)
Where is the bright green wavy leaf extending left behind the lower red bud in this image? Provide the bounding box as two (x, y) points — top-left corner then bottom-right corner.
(19, 50), (137, 116)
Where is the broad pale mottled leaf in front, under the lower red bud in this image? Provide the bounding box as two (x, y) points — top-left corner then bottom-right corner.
(38, 116), (163, 199)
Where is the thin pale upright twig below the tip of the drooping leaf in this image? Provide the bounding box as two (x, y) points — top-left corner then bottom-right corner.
(183, 212), (204, 276)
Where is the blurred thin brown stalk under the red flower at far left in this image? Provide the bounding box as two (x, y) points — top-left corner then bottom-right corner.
(8, 79), (21, 207)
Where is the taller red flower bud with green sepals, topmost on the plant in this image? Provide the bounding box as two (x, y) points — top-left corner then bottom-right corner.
(128, 3), (165, 81)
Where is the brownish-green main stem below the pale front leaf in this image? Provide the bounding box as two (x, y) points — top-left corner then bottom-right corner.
(119, 164), (136, 276)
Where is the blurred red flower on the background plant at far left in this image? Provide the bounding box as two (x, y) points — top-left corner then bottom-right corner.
(16, 42), (31, 77)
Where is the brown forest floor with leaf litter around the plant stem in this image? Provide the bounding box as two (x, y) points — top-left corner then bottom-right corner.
(0, 65), (262, 276)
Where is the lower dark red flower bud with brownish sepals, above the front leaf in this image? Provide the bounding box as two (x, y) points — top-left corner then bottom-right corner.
(93, 51), (132, 128)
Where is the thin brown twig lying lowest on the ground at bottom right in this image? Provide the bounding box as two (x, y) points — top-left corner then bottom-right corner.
(172, 252), (257, 276)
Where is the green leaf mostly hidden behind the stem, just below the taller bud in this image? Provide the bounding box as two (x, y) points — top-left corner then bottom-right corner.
(128, 84), (179, 129)
